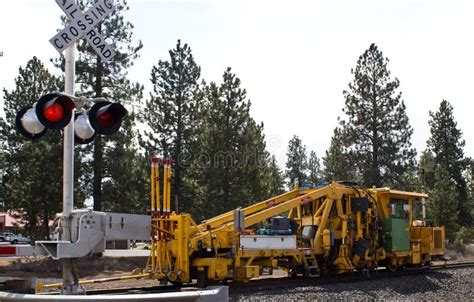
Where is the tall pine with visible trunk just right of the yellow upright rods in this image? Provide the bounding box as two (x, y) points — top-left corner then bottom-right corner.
(141, 40), (201, 209)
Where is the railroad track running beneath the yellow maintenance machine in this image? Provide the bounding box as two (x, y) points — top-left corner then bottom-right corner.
(38, 262), (474, 295)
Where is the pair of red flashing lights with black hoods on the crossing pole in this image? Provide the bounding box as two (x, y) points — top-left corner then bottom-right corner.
(15, 93), (127, 144)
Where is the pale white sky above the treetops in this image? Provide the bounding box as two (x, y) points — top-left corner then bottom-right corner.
(0, 0), (474, 168)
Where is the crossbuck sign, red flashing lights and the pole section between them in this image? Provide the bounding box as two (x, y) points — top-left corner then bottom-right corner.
(21, 0), (127, 144)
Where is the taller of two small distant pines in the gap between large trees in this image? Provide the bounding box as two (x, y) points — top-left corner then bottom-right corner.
(285, 135), (308, 189)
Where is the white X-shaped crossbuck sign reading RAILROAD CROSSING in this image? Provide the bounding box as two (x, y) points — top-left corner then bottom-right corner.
(49, 0), (115, 61)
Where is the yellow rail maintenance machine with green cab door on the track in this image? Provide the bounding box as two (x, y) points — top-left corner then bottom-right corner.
(143, 158), (444, 286)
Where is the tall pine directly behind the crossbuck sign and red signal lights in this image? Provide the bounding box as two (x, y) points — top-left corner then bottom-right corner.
(53, 0), (146, 211)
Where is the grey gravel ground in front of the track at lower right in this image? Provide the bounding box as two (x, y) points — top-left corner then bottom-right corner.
(231, 268), (474, 302)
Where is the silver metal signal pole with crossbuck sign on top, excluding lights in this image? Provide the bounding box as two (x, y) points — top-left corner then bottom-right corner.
(49, 0), (116, 294)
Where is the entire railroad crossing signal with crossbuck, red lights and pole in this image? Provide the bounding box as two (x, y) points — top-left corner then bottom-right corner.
(41, 0), (122, 294)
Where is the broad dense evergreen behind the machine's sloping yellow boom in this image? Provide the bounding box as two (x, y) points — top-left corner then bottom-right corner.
(191, 68), (269, 217)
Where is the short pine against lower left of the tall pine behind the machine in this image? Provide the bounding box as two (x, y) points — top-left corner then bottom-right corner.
(323, 128), (358, 182)
